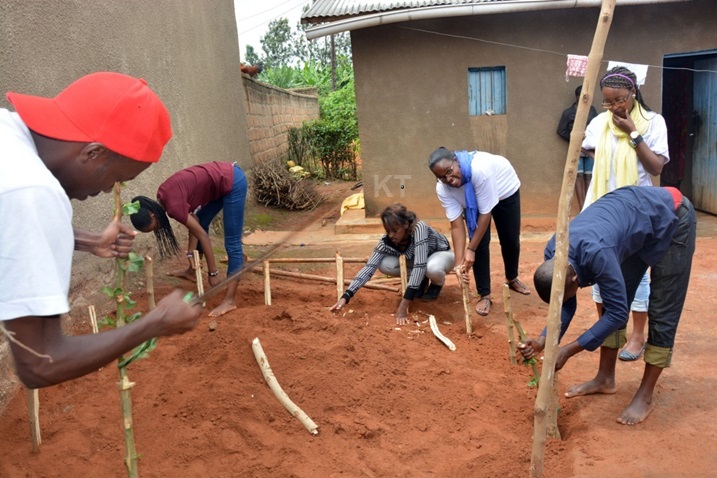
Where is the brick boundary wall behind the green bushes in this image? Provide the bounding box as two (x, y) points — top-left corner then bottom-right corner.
(242, 75), (319, 162)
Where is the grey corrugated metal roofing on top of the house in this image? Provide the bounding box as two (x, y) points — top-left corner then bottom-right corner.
(301, 0), (510, 23)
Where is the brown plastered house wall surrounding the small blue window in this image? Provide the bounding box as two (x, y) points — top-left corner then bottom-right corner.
(351, 0), (717, 223)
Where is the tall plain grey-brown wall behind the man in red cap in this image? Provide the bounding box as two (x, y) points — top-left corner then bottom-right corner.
(0, 0), (251, 302)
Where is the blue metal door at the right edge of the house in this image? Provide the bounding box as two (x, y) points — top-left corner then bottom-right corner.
(692, 57), (717, 214)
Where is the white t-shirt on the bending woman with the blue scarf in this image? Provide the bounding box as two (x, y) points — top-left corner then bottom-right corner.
(436, 151), (520, 222)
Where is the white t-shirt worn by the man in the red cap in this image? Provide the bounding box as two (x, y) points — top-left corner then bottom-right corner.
(0, 108), (75, 320)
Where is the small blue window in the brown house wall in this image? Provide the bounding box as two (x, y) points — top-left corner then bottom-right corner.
(468, 66), (506, 116)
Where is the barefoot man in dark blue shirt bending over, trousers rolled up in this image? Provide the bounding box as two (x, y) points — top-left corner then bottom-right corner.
(519, 186), (697, 425)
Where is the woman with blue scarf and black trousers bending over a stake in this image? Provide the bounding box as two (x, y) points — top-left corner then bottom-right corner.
(428, 147), (530, 315)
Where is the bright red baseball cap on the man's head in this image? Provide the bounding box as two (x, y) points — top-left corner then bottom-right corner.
(6, 72), (172, 163)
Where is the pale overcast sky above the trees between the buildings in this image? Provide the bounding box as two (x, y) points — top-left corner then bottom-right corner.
(234, 0), (311, 60)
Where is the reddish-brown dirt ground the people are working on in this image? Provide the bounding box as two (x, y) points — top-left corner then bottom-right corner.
(0, 184), (717, 478)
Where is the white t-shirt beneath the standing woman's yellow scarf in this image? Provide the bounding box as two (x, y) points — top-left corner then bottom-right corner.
(582, 111), (670, 210)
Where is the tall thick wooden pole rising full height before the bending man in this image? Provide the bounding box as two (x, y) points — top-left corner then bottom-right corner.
(530, 0), (615, 477)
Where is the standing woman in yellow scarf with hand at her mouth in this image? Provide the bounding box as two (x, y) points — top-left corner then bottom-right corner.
(582, 66), (670, 361)
